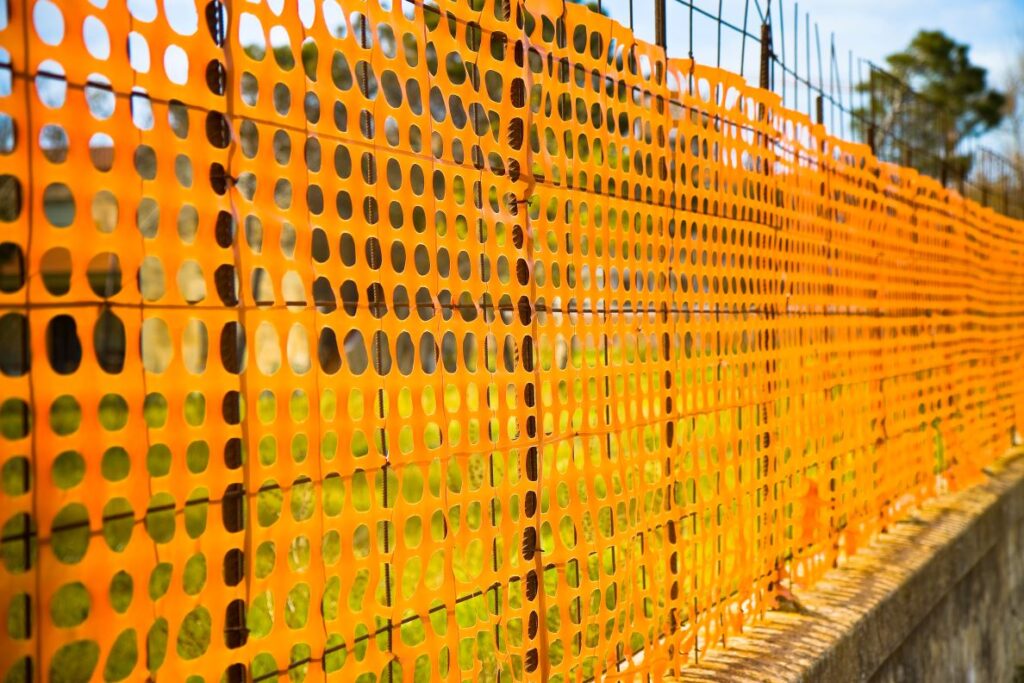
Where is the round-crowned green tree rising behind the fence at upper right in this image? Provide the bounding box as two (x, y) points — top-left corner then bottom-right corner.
(858, 31), (1007, 180)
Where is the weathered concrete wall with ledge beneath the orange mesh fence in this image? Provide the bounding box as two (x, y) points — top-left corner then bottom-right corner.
(678, 451), (1024, 681)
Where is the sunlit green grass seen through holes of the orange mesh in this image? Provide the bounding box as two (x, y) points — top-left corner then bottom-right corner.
(9, 376), (966, 681)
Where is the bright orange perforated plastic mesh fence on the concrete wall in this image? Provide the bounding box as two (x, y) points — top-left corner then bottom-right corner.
(0, 0), (1024, 683)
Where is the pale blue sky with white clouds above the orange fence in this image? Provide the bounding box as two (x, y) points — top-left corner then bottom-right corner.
(28, 0), (1024, 145)
